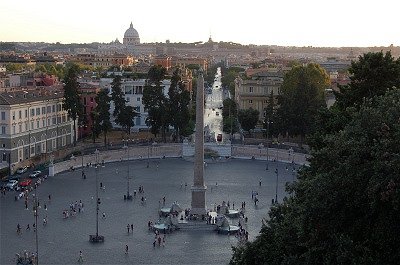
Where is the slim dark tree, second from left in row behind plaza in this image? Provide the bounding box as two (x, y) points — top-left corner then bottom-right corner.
(93, 90), (112, 146)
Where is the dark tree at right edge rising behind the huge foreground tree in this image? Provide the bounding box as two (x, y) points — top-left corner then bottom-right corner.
(335, 51), (400, 109)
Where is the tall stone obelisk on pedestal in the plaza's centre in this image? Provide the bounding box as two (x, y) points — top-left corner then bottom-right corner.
(190, 69), (207, 215)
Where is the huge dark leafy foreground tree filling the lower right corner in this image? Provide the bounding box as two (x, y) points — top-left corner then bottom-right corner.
(230, 89), (400, 264)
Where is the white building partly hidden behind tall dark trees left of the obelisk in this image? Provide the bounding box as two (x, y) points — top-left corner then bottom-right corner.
(100, 78), (171, 131)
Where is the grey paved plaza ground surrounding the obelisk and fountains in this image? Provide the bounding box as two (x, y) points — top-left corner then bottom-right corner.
(0, 158), (294, 265)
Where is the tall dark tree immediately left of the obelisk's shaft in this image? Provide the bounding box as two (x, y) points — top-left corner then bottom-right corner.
(168, 68), (190, 139)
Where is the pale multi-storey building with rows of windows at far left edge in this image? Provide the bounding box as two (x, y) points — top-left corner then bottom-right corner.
(0, 87), (73, 170)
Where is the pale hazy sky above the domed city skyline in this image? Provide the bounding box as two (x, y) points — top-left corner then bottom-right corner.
(0, 0), (400, 47)
